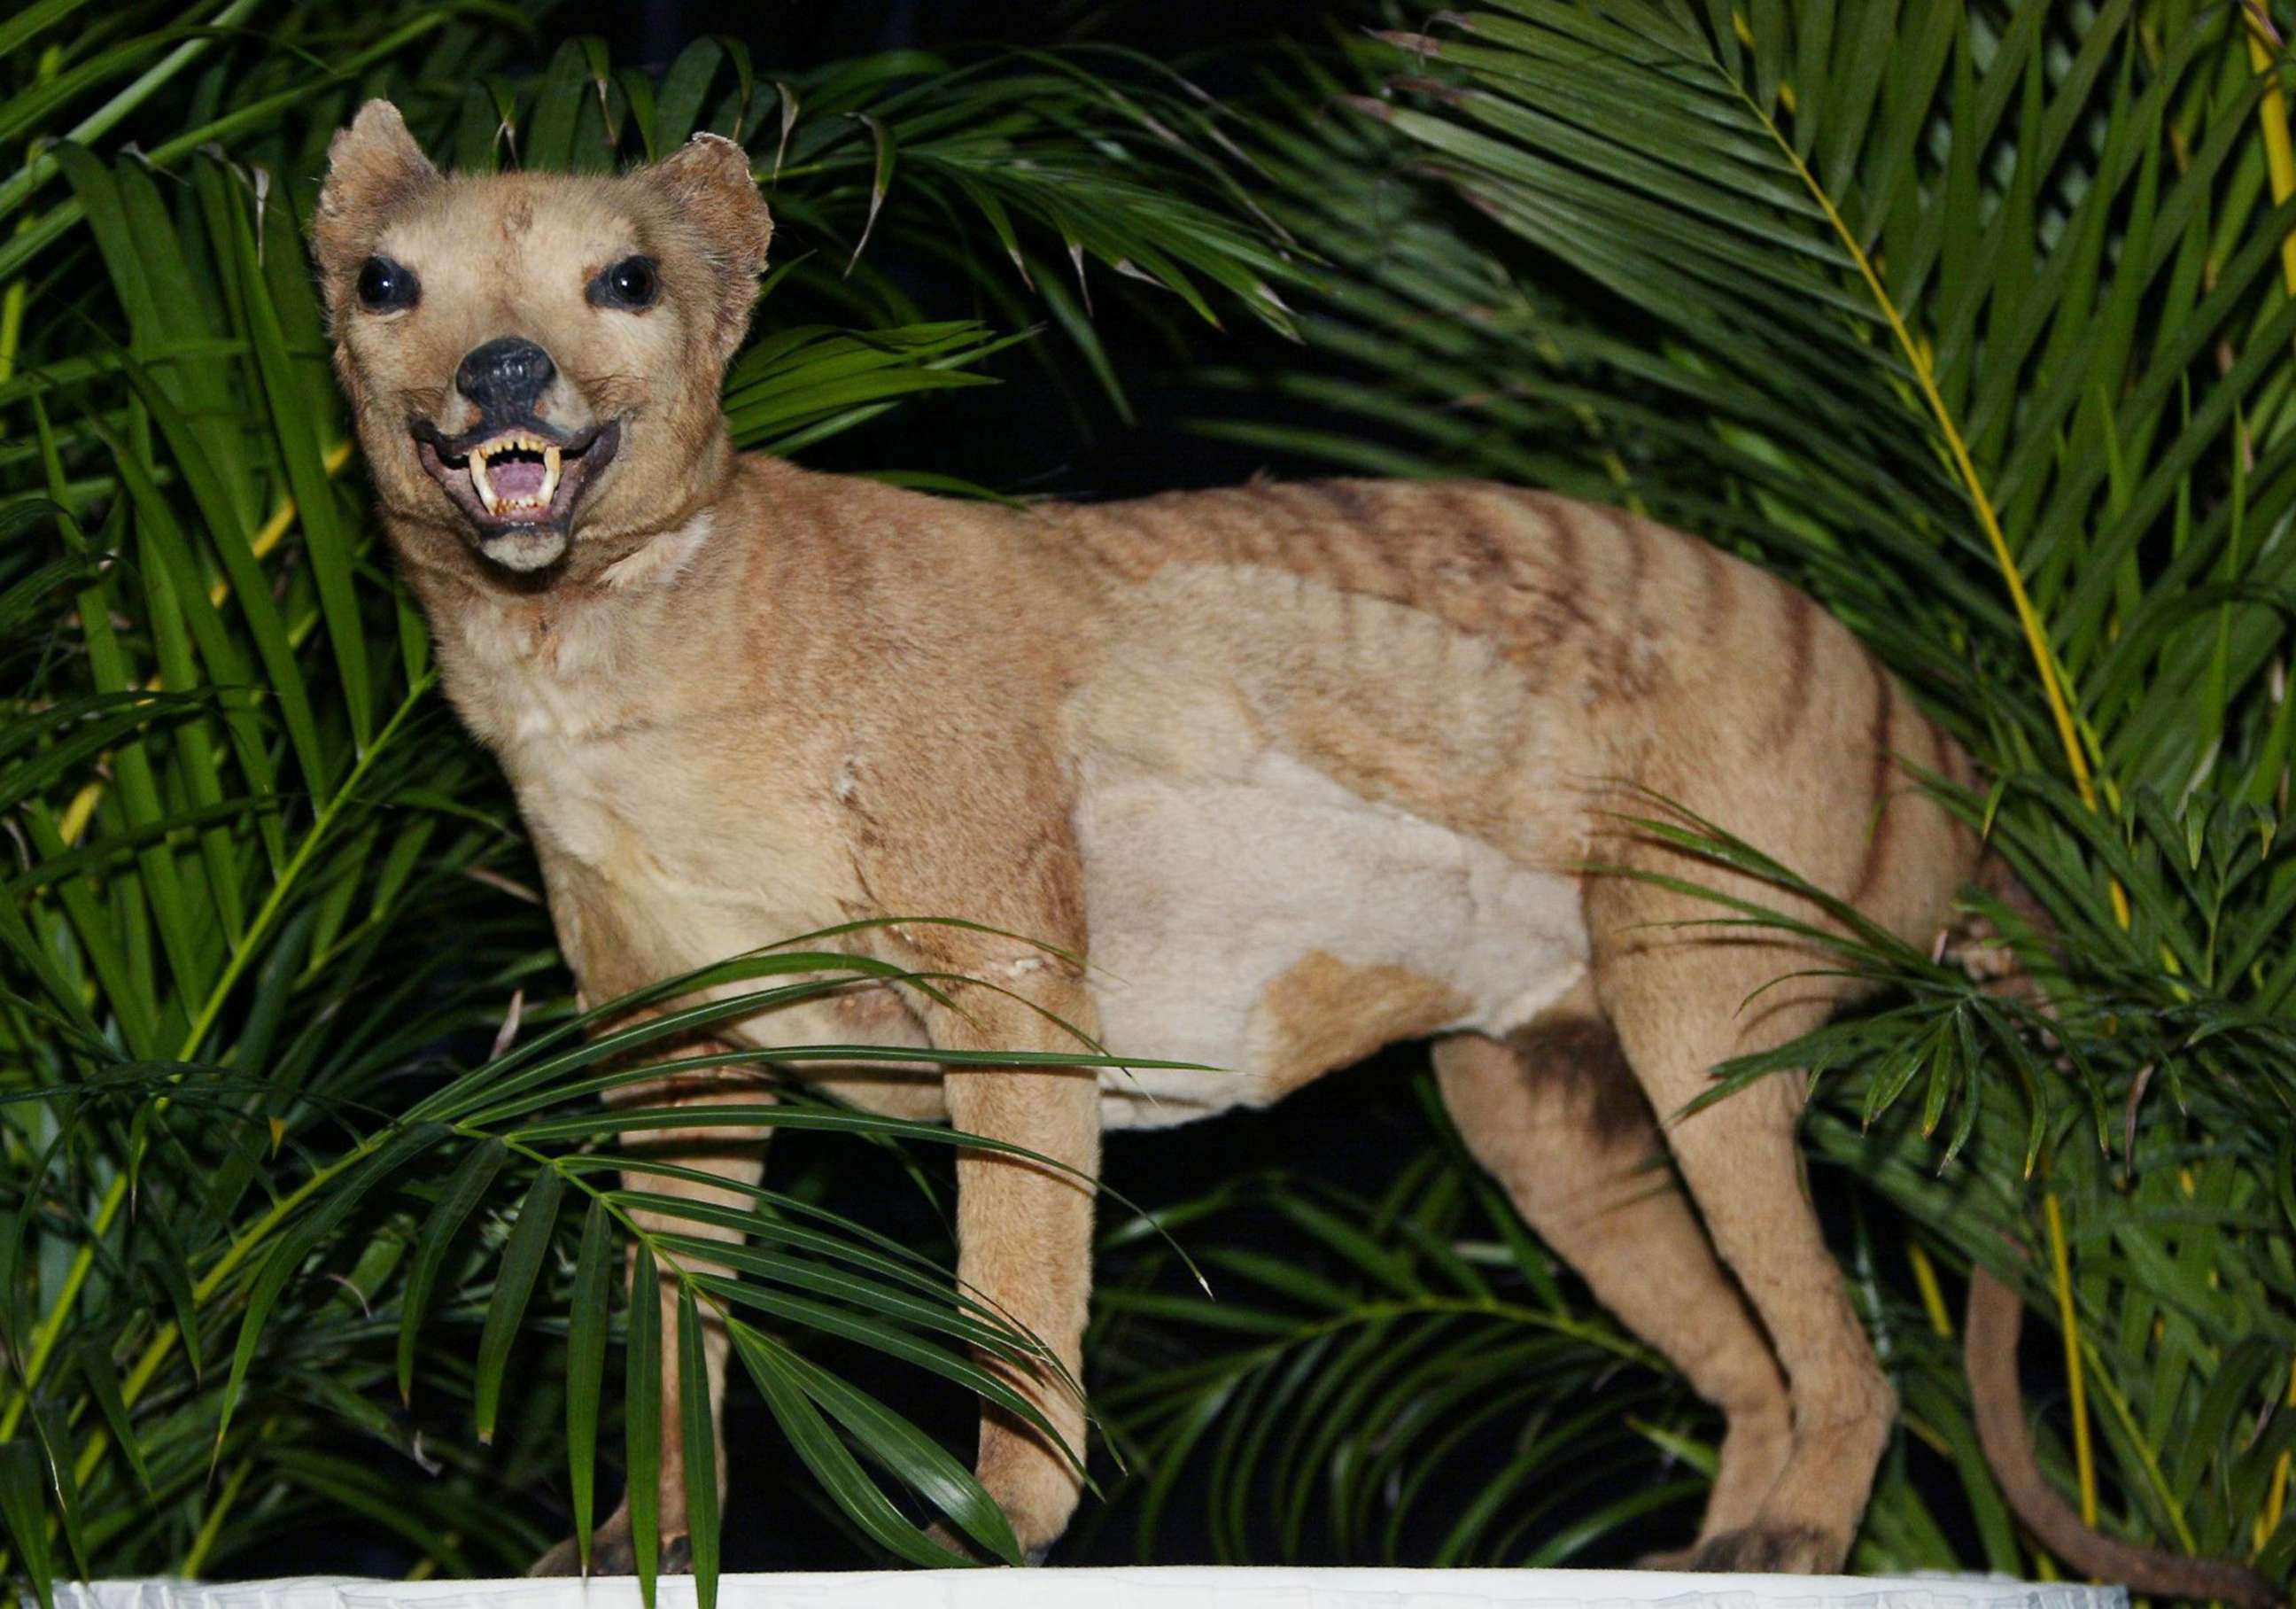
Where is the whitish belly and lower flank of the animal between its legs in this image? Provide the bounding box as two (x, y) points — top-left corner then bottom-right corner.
(1077, 750), (1586, 1127)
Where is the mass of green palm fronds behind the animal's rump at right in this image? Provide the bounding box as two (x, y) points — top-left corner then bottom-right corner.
(1206, 0), (2296, 1577)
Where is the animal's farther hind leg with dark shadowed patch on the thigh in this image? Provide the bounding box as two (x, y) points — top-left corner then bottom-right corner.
(1435, 987), (1791, 1566)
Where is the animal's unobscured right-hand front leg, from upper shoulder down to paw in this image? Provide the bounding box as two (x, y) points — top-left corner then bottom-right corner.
(845, 706), (1100, 1558)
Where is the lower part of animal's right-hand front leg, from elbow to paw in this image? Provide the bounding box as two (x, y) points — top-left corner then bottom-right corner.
(927, 957), (1100, 1563)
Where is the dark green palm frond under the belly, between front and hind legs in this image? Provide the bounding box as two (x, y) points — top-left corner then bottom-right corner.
(1095, 1143), (1713, 1566)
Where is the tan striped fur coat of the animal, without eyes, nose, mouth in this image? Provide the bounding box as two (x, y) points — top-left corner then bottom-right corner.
(317, 105), (1974, 1567)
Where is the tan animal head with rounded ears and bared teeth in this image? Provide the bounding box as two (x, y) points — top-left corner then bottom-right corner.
(313, 101), (774, 571)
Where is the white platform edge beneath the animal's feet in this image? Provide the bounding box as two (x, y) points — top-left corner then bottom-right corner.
(40, 1567), (2129, 1609)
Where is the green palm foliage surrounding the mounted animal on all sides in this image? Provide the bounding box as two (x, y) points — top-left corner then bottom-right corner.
(0, 0), (2296, 1582)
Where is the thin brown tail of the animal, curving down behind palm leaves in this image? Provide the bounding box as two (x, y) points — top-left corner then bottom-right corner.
(1947, 854), (2287, 1609)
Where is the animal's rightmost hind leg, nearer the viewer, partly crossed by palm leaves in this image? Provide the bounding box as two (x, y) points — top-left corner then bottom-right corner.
(1586, 877), (1897, 1573)
